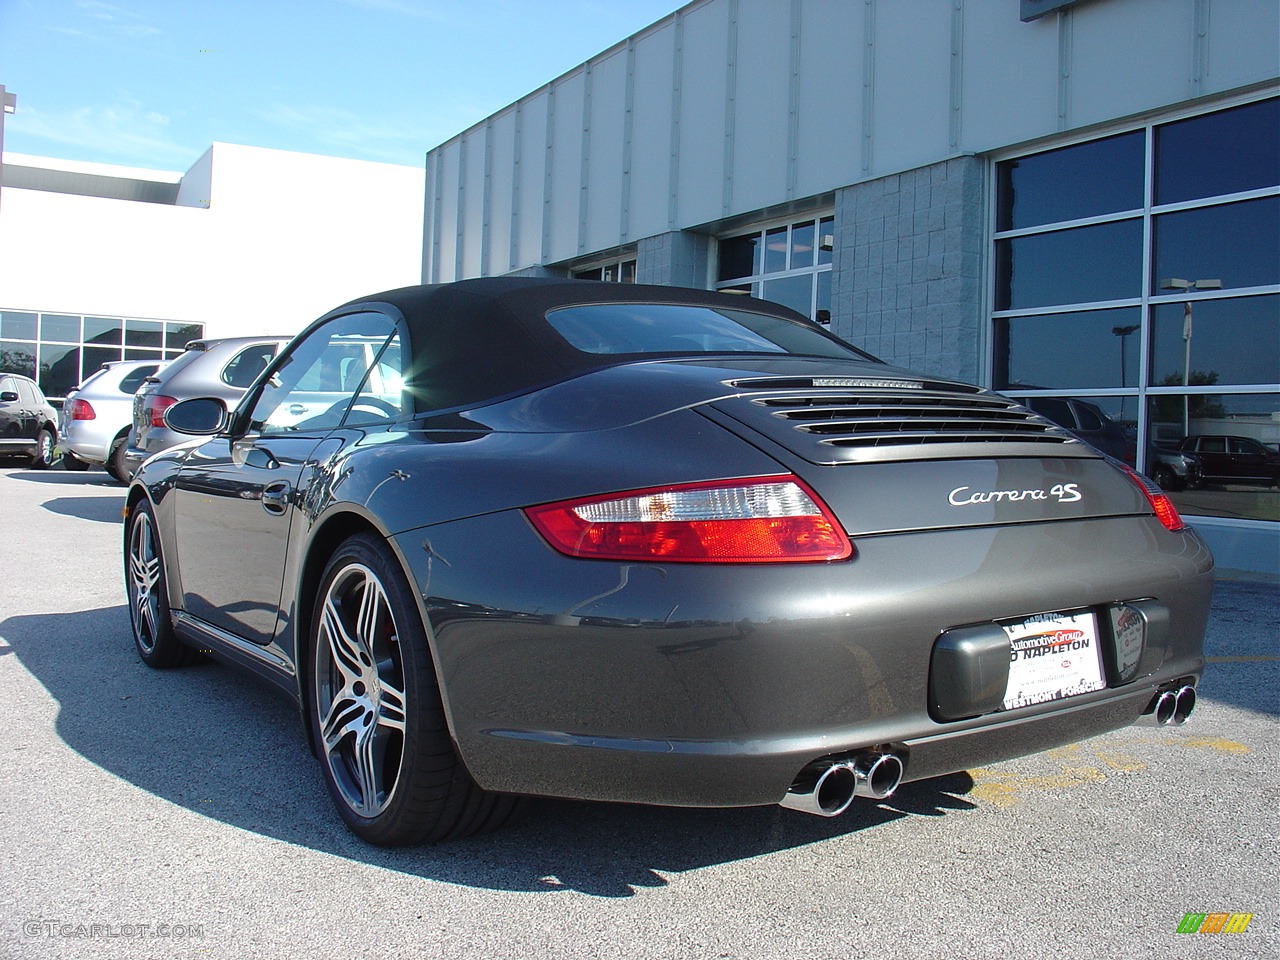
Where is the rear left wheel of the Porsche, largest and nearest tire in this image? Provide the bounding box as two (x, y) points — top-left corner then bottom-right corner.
(308, 534), (522, 846)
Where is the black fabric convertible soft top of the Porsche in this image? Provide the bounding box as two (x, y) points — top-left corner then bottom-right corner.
(334, 276), (852, 413)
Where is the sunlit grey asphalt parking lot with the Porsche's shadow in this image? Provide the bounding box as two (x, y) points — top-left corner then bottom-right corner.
(0, 463), (1280, 960)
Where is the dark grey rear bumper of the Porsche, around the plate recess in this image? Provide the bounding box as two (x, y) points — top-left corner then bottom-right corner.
(397, 512), (1212, 806)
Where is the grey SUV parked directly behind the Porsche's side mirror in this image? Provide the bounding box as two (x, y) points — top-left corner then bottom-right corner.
(123, 337), (289, 476)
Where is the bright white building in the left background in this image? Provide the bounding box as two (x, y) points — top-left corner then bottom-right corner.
(0, 143), (424, 397)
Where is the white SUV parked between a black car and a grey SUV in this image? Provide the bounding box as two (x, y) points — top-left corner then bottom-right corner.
(58, 360), (166, 483)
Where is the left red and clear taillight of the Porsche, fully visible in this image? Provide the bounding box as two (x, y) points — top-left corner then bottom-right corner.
(525, 476), (854, 563)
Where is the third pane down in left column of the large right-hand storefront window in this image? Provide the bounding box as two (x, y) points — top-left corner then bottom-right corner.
(992, 307), (1142, 390)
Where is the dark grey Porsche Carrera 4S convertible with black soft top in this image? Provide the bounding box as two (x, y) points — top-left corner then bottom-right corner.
(124, 273), (1213, 845)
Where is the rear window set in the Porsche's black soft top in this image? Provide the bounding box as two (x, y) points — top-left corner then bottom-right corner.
(547, 303), (868, 360)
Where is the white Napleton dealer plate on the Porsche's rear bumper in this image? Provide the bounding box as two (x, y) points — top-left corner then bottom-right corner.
(1002, 612), (1107, 710)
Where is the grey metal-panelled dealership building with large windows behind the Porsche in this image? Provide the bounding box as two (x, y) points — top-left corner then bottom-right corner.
(422, 0), (1280, 572)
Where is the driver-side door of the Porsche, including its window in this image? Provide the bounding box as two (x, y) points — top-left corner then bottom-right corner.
(173, 312), (394, 644)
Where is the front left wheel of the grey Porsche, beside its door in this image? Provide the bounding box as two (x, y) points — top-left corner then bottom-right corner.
(124, 499), (196, 669)
